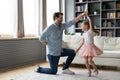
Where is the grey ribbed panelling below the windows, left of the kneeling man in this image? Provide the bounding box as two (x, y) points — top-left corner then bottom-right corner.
(0, 38), (46, 69)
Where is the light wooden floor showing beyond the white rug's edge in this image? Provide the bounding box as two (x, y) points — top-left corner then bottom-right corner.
(0, 62), (118, 80)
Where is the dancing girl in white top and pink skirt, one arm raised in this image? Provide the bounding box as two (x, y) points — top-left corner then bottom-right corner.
(76, 14), (103, 77)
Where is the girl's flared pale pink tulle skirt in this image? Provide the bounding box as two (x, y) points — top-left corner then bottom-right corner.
(77, 43), (103, 57)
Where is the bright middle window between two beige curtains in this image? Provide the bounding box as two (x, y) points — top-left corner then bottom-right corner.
(23, 0), (39, 36)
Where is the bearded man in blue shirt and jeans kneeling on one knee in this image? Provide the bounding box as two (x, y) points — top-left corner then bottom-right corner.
(36, 12), (85, 74)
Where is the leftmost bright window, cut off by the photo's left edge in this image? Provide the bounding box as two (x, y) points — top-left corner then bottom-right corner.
(0, 0), (17, 37)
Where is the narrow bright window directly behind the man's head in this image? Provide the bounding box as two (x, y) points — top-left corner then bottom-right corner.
(47, 0), (59, 26)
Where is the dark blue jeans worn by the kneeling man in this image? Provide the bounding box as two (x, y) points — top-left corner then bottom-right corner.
(38, 48), (75, 74)
